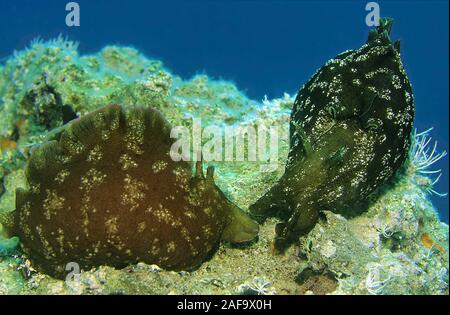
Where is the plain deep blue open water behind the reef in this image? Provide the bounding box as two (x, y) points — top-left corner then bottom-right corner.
(0, 0), (449, 222)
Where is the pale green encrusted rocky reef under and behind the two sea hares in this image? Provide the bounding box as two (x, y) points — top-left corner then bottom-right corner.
(0, 38), (449, 294)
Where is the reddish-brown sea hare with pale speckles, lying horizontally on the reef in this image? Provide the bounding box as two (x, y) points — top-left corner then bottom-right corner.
(9, 105), (258, 277)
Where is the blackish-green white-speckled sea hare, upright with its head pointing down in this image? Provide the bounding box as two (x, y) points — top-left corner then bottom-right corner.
(250, 19), (414, 249)
